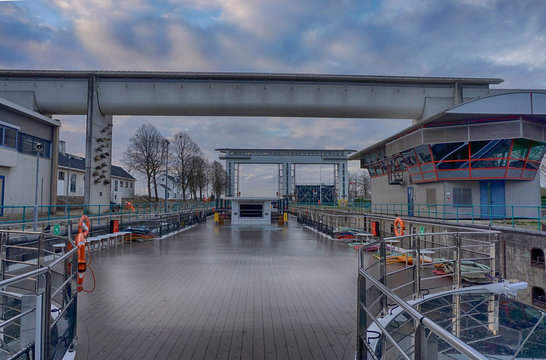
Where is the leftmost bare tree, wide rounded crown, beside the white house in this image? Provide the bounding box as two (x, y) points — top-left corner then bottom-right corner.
(122, 124), (165, 201)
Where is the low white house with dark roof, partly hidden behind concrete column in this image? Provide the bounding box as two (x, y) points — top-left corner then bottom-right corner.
(57, 141), (135, 204)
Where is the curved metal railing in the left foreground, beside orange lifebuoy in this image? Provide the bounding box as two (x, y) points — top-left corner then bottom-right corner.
(0, 230), (77, 359)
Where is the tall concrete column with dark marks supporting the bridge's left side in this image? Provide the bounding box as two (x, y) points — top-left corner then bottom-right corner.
(84, 75), (113, 214)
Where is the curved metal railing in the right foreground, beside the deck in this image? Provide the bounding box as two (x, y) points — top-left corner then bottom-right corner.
(357, 231), (504, 359)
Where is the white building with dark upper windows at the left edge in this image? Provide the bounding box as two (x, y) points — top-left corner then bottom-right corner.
(0, 98), (61, 217)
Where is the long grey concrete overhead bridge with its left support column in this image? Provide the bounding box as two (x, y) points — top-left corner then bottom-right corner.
(0, 70), (502, 210)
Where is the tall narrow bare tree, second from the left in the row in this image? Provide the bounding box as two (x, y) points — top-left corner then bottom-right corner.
(172, 131), (201, 201)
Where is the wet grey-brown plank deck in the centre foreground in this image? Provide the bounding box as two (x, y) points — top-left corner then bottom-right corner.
(77, 219), (357, 360)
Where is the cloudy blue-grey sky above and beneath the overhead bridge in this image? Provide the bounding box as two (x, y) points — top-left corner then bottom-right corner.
(0, 0), (546, 195)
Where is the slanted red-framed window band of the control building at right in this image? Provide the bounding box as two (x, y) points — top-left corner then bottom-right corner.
(361, 138), (546, 183)
